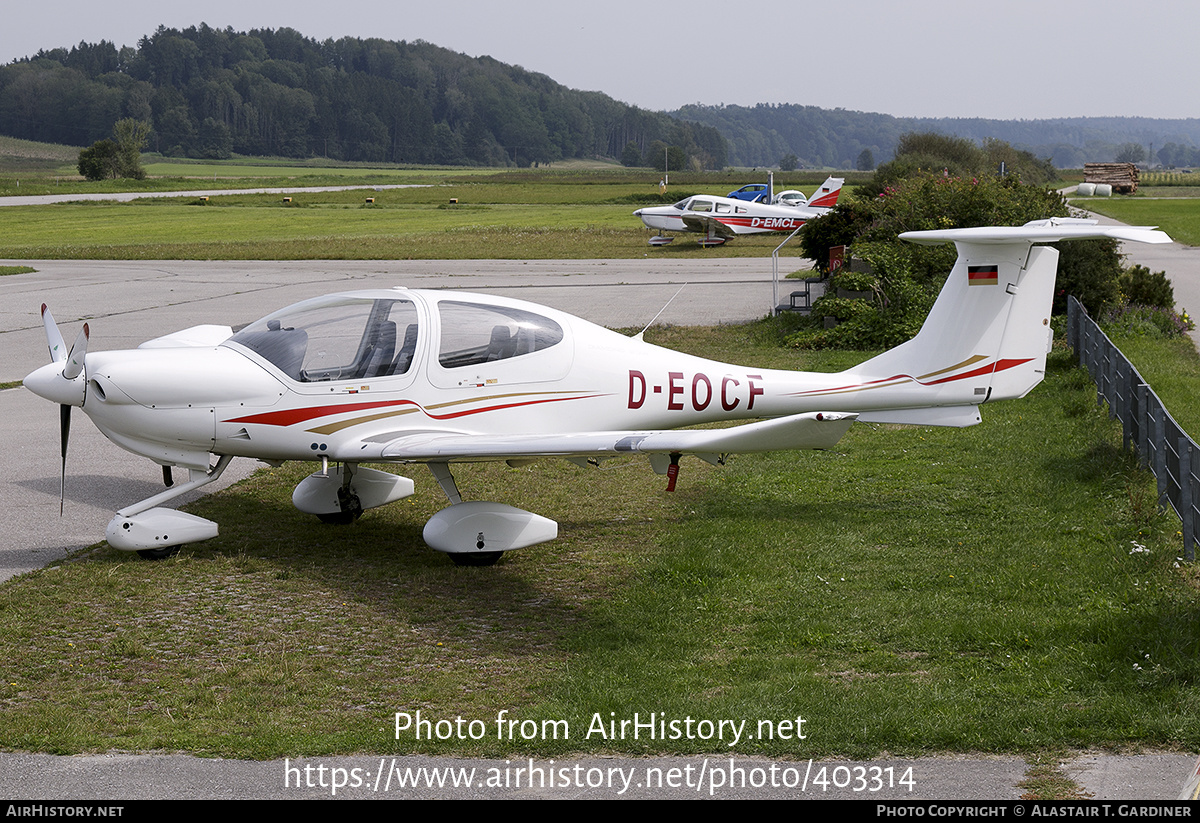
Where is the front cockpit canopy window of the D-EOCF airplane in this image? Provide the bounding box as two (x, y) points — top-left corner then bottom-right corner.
(228, 295), (418, 383)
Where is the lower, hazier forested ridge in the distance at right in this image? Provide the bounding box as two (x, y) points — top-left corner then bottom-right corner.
(671, 103), (1200, 168)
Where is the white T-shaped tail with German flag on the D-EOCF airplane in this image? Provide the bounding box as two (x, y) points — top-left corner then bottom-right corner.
(847, 218), (1171, 426)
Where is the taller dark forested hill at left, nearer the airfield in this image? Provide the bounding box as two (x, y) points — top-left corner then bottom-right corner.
(0, 25), (727, 168)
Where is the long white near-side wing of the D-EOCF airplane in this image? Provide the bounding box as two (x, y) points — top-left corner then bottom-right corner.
(330, 412), (858, 463)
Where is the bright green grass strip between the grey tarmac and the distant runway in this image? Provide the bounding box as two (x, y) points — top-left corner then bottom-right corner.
(0, 195), (816, 259)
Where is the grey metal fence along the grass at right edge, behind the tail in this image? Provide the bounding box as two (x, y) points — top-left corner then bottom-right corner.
(1067, 298), (1200, 560)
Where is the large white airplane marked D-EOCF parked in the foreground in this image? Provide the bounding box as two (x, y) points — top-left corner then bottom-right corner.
(25, 220), (1170, 565)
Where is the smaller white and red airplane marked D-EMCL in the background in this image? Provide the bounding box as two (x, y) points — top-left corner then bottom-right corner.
(634, 178), (845, 246)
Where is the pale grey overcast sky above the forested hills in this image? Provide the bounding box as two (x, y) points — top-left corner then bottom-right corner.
(0, 0), (1200, 119)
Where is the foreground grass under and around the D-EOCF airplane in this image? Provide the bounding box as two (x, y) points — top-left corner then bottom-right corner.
(0, 324), (1200, 758)
